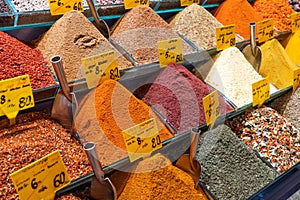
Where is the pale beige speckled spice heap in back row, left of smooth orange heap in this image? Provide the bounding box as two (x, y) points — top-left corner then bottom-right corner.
(170, 4), (242, 50)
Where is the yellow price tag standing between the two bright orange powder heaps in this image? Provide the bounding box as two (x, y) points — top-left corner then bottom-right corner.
(122, 118), (162, 162)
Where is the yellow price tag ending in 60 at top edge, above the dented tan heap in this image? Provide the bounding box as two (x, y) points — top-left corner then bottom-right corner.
(48, 0), (84, 15)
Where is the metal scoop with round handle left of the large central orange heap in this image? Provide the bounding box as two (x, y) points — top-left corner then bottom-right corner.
(50, 56), (73, 129)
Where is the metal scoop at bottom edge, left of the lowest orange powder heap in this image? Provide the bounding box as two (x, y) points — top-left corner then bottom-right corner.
(83, 142), (117, 200)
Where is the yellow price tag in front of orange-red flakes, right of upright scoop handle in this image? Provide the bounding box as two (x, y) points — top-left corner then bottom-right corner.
(256, 19), (274, 43)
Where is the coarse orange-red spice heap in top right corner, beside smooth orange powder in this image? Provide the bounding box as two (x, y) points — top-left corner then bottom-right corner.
(253, 0), (295, 31)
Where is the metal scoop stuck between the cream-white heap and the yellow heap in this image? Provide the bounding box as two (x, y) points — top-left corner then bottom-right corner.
(242, 22), (262, 72)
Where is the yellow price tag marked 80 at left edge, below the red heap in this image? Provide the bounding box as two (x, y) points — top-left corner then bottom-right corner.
(0, 75), (34, 125)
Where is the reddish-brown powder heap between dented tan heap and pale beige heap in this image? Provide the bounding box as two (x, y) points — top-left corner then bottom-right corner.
(111, 6), (193, 64)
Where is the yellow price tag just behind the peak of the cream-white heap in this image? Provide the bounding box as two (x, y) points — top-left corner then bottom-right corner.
(216, 24), (235, 51)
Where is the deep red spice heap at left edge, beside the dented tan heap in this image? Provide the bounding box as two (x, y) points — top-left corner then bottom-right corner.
(0, 31), (55, 89)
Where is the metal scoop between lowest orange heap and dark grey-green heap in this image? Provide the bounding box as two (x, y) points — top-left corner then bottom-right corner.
(175, 128), (201, 189)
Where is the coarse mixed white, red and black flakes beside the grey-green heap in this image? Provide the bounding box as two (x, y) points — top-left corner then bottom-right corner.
(227, 107), (300, 173)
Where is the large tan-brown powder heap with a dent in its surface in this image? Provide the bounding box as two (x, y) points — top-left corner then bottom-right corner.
(37, 10), (132, 81)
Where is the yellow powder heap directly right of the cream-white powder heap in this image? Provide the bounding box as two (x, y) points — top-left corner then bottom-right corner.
(259, 39), (299, 89)
